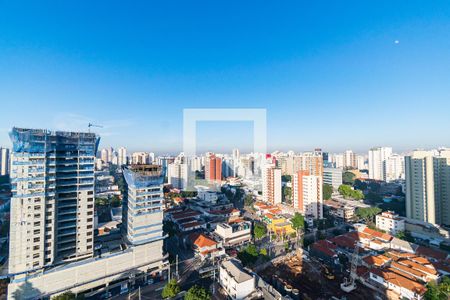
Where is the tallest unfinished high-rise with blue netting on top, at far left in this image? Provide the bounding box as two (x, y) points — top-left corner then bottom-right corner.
(9, 128), (99, 273)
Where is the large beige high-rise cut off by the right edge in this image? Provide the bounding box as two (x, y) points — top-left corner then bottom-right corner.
(405, 150), (450, 225)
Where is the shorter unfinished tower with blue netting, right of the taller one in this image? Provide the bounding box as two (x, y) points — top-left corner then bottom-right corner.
(123, 165), (164, 246)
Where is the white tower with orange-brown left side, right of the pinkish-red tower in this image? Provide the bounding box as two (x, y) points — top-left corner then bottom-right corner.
(292, 171), (323, 219)
